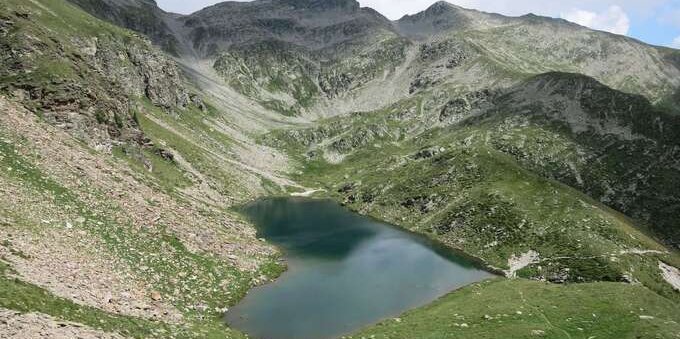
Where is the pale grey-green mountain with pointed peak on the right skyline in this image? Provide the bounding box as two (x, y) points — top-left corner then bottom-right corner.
(398, 2), (678, 101)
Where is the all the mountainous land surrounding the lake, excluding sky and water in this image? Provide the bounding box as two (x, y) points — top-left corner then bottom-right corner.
(0, 0), (680, 339)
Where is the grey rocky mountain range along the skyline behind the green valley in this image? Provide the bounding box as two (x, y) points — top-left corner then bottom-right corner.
(67, 0), (680, 116)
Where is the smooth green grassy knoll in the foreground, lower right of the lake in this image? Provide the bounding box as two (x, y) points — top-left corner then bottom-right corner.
(351, 279), (680, 339)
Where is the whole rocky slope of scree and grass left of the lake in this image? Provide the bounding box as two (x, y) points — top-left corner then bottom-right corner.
(0, 1), (292, 338)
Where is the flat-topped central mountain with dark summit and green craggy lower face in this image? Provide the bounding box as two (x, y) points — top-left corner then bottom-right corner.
(175, 0), (409, 115)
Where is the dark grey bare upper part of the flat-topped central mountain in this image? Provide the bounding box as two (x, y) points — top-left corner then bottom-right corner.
(180, 0), (391, 56)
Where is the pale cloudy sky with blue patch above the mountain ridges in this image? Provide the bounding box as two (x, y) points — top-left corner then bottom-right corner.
(156, 0), (680, 49)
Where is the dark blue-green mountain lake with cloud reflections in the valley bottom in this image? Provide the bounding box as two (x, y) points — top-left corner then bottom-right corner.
(226, 198), (491, 339)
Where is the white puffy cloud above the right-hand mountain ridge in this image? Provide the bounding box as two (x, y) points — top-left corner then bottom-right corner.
(561, 5), (630, 35)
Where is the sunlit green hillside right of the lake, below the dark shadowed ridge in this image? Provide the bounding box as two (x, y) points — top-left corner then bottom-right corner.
(282, 119), (678, 295)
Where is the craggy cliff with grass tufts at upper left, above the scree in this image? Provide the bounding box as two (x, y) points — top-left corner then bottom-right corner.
(0, 0), (200, 148)
